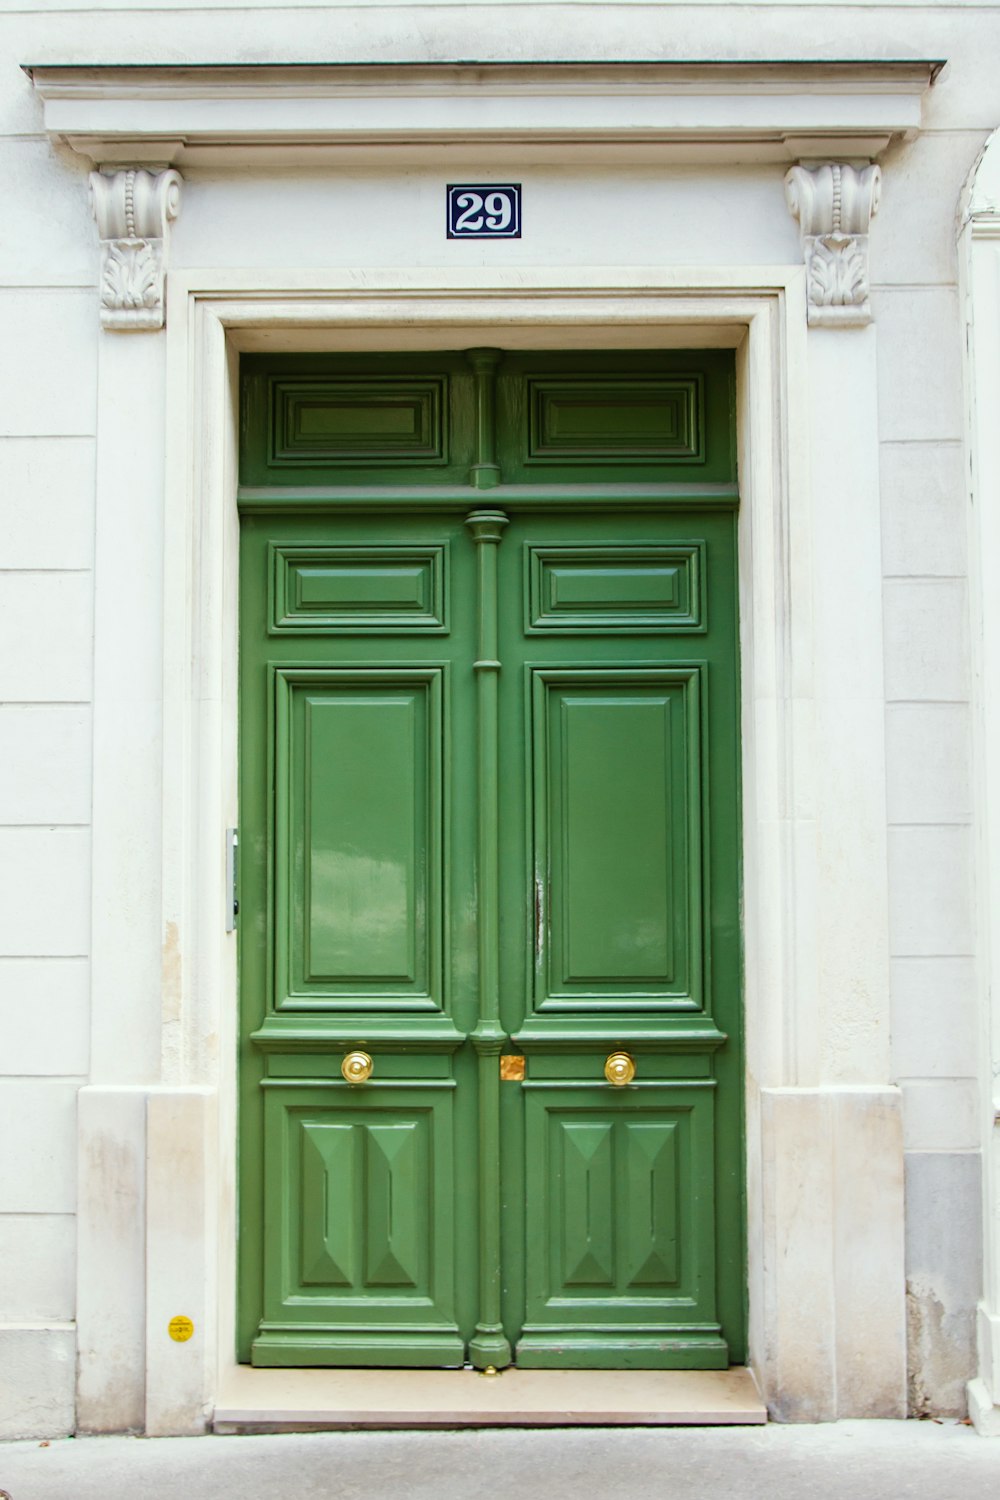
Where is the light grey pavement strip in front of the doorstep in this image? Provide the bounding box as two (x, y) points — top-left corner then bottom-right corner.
(0, 1422), (1000, 1500)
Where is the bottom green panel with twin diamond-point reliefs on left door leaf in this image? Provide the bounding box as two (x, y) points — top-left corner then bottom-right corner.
(252, 1080), (465, 1365)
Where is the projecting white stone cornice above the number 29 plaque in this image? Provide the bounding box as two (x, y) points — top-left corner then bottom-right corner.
(27, 62), (942, 167)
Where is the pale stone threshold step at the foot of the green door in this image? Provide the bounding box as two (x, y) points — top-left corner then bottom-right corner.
(213, 1365), (768, 1433)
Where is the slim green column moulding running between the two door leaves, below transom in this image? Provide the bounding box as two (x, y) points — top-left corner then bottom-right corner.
(466, 507), (511, 1370)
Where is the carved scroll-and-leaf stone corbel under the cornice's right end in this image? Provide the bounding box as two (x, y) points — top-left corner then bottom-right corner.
(784, 162), (882, 327)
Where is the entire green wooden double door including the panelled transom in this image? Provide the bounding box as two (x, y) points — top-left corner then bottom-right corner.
(238, 351), (745, 1368)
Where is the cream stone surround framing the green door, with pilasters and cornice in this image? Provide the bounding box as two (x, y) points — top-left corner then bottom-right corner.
(36, 65), (931, 1434)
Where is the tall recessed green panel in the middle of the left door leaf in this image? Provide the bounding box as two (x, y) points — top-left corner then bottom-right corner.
(274, 669), (444, 1010)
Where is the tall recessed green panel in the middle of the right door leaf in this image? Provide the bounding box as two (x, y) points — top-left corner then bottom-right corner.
(532, 668), (702, 1011)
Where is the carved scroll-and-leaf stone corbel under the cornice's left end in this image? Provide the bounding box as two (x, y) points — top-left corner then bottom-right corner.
(90, 167), (181, 332)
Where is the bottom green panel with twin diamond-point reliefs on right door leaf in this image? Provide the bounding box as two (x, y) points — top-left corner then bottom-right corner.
(517, 1080), (729, 1368)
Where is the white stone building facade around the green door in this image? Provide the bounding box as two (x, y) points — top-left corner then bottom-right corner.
(0, 0), (1000, 1436)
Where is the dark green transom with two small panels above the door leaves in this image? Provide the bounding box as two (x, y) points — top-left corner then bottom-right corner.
(240, 350), (736, 492)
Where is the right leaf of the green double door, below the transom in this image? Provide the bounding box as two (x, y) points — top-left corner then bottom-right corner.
(499, 504), (742, 1368)
